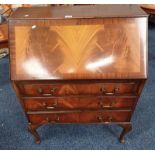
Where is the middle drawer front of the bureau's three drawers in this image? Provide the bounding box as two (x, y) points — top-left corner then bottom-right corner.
(24, 97), (135, 111)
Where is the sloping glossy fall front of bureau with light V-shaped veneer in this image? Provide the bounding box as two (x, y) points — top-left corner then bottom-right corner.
(11, 18), (147, 80)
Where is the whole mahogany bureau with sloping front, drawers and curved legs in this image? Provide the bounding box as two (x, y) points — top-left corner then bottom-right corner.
(9, 5), (148, 143)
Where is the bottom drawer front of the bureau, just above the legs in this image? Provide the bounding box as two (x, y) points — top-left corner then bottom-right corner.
(28, 111), (131, 124)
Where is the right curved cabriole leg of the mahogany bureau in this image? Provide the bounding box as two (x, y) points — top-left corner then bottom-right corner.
(119, 123), (132, 143)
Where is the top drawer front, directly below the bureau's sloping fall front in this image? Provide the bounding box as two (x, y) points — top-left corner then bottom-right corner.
(20, 83), (138, 97)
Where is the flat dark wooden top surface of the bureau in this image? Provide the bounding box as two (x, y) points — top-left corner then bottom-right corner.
(10, 4), (147, 19)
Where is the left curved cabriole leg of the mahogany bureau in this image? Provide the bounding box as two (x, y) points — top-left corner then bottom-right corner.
(28, 124), (41, 144)
